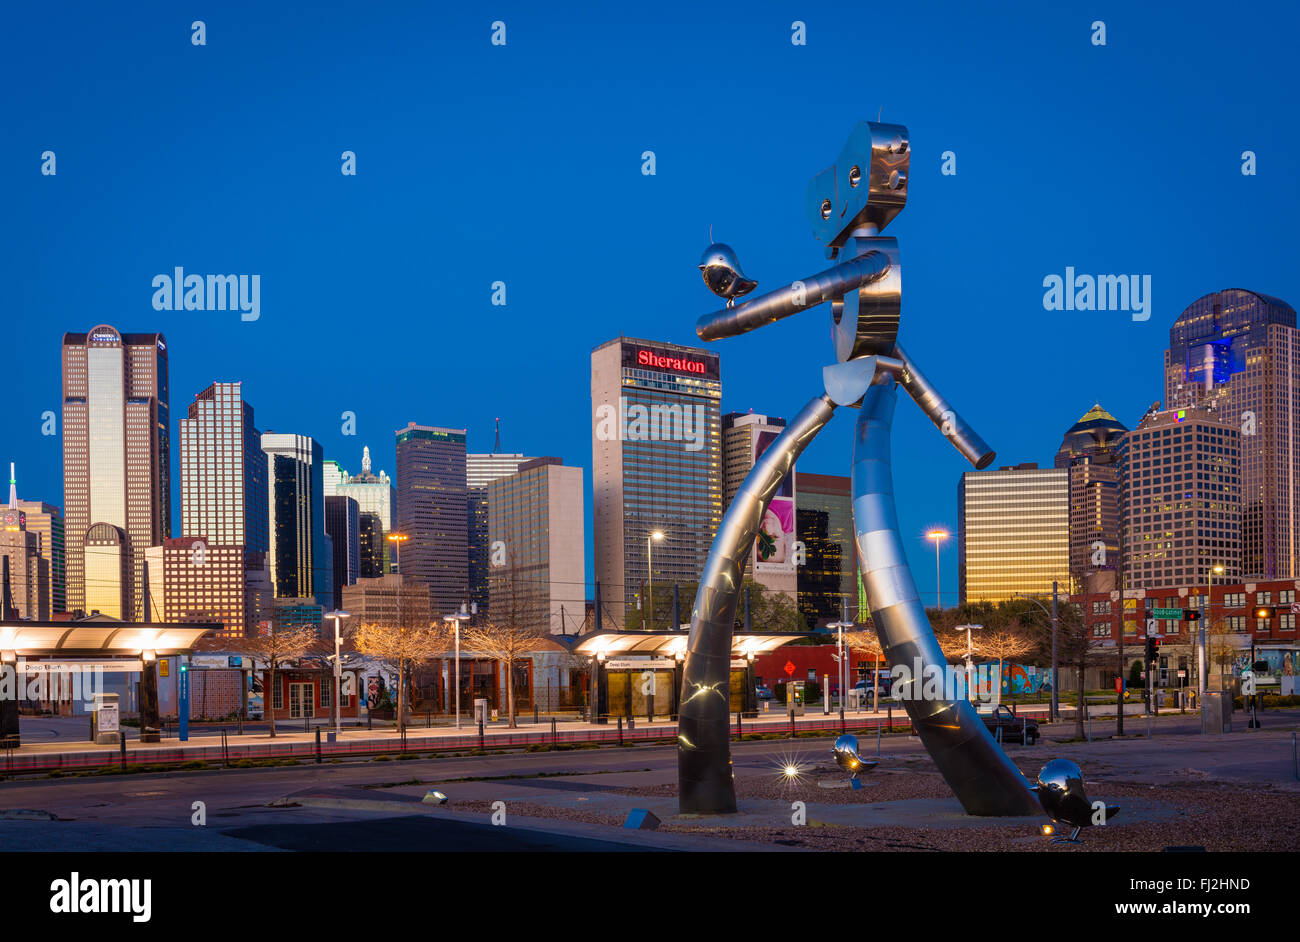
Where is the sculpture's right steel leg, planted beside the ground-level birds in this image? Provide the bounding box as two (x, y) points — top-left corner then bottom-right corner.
(853, 374), (1039, 816)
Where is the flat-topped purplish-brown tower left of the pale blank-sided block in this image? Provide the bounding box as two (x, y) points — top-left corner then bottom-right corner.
(397, 422), (469, 616)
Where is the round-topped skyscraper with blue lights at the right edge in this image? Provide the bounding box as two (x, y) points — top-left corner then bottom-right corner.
(1165, 288), (1300, 578)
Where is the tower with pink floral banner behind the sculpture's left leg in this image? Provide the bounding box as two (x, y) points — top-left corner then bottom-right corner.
(723, 412), (798, 600)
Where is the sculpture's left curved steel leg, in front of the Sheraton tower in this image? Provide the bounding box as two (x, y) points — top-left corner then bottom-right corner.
(677, 396), (835, 815)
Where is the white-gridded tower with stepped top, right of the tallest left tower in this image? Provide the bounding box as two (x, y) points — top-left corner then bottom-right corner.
(178, 383), (270, 637)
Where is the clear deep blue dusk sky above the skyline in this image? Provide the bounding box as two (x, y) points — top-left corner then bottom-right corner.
(0, 1), (1300, 599)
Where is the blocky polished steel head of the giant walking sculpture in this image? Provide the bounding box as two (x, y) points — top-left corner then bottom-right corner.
(803, 121), (911, 259)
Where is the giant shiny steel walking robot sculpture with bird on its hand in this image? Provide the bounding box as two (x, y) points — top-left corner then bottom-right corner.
(677, 122), (1039, 815)
